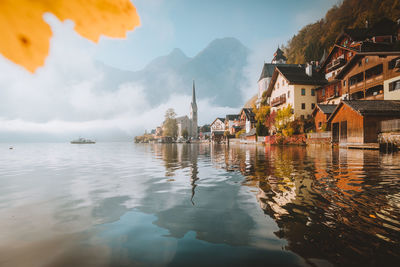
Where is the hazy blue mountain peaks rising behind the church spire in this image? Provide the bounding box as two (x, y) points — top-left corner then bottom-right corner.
(98, 38), (249, 107)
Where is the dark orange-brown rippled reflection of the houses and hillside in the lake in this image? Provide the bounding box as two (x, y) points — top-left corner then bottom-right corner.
(219, 146), (400, 266)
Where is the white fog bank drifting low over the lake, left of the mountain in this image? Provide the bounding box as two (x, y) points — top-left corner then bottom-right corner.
(0, 15), (238, 141)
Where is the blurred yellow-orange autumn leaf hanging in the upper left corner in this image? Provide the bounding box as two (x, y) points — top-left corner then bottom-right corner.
(0, 0), (140, 72)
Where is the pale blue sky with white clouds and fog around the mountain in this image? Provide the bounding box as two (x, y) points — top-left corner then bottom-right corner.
(0, 0), (336, 142)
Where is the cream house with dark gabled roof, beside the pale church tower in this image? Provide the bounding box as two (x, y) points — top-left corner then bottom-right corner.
(267, 65), (326, 118)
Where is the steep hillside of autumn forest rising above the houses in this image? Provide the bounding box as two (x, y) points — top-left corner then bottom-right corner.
(284, 0), (400, 63)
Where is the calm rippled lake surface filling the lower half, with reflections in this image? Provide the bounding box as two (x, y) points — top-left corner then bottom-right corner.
(0, 143), (400, 267)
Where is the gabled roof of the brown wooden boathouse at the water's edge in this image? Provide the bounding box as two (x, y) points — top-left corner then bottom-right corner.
(328, 100), (400, 122)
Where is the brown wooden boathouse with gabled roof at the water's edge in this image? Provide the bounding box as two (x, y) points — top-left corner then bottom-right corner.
(328, 100), (400, 145)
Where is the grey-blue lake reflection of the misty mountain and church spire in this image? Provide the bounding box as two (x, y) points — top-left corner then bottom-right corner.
(140, 144), (254, 245)
